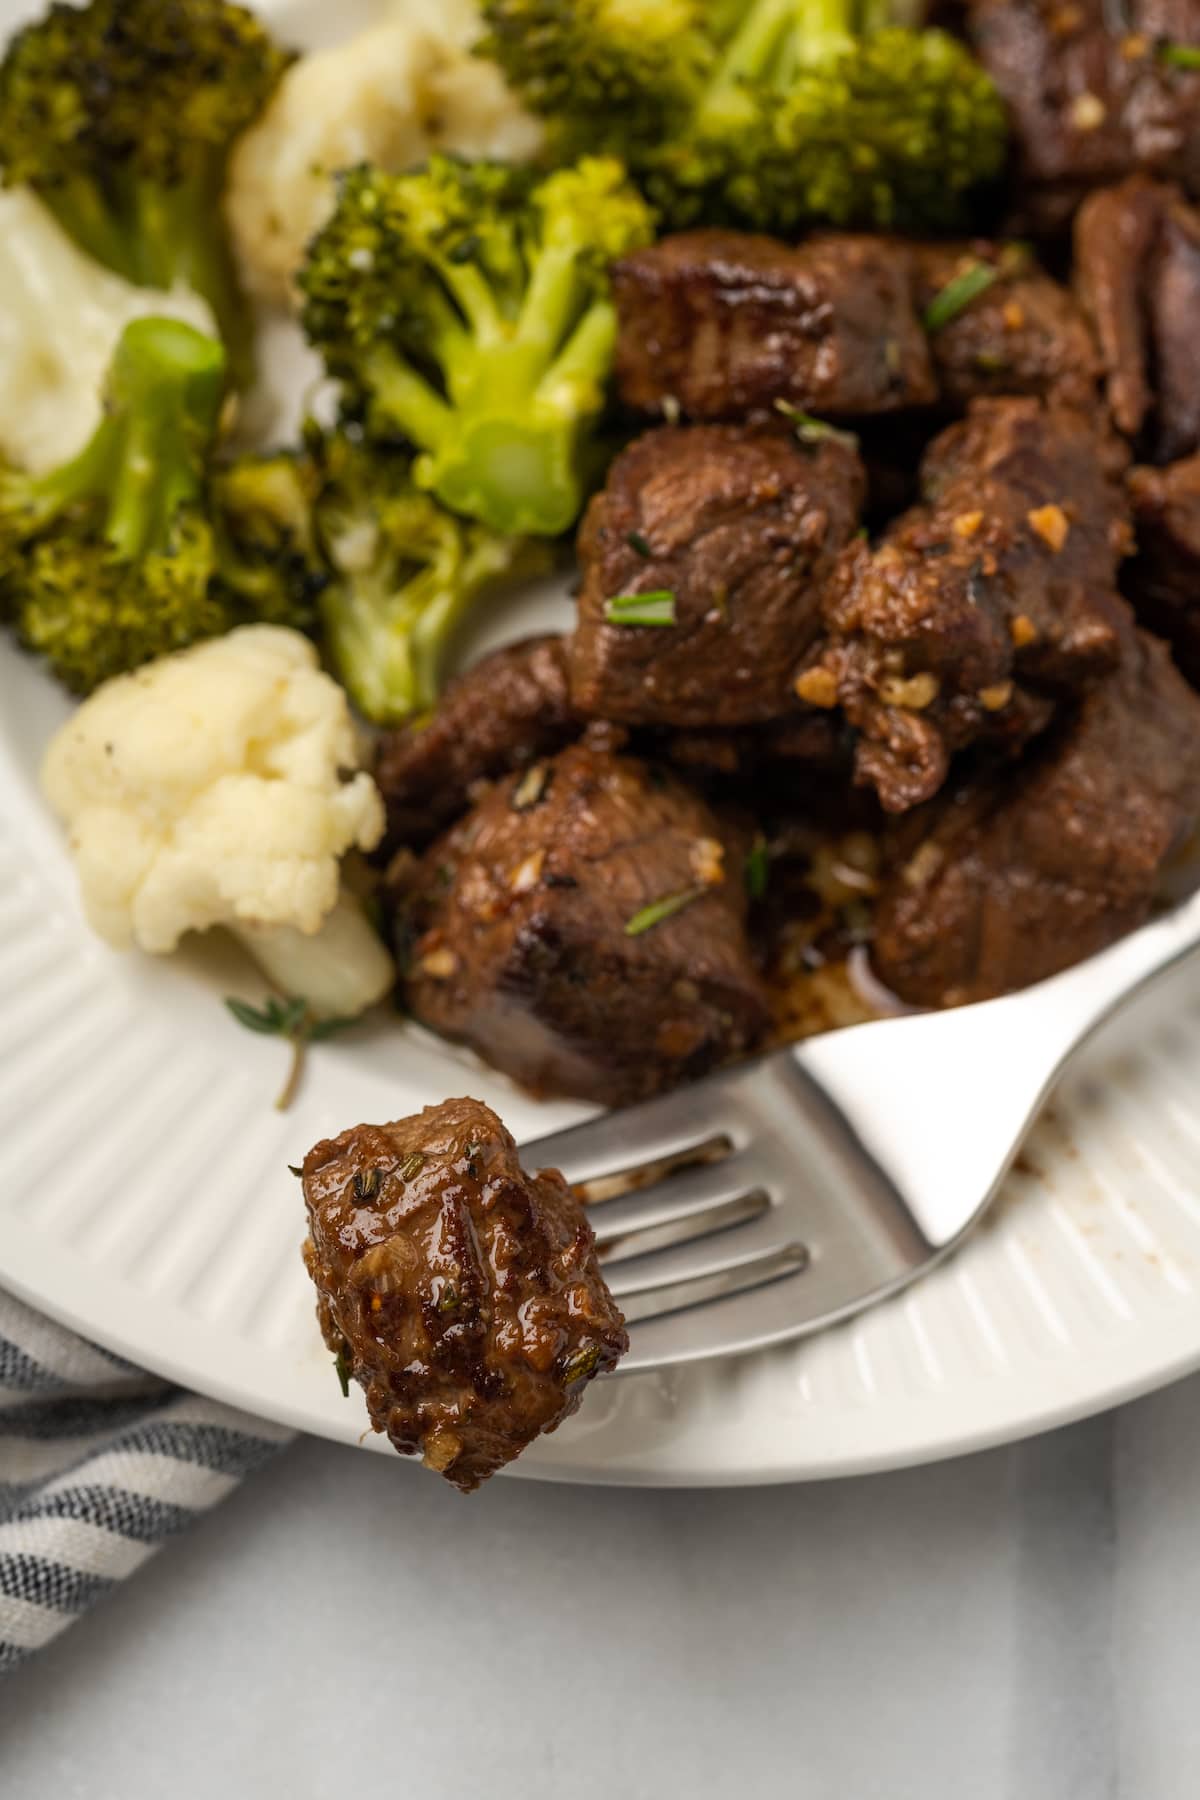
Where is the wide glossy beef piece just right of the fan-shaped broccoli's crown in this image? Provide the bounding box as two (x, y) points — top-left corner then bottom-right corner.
(613, 230), (936, 419)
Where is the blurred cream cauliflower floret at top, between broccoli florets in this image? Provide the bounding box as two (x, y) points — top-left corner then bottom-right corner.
(225, 0), (542, 306)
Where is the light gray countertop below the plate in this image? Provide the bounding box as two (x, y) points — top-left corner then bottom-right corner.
(0, 1379), (1200, 1800)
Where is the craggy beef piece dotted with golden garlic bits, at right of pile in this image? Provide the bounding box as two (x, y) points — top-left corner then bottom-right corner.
(797, 400), (1130, 812)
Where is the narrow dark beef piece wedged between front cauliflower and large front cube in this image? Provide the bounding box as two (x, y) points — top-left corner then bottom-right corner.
(374, 637), (583, 850)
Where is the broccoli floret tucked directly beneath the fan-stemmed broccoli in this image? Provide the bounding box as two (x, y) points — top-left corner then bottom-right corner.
(317, 432), (549, 725)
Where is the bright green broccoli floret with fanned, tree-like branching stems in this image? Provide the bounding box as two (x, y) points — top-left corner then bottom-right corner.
(300, 157), (651, 536)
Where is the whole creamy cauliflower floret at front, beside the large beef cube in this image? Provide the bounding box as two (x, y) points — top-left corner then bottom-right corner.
(41, 625), (394, 1017)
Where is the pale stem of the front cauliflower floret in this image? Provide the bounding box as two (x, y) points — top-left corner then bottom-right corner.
(228, 889), (396, 1019)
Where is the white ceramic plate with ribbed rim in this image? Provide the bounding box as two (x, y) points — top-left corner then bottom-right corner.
(0, 0), (1200, 1483)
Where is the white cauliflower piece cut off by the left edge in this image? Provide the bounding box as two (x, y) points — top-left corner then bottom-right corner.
(0, 187), (216, 473)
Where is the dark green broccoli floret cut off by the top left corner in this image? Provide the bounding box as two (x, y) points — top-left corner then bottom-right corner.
(0, 0), (290, 380)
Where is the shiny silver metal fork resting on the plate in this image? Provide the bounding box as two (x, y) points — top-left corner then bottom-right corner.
(522, 895), (1200, 1372)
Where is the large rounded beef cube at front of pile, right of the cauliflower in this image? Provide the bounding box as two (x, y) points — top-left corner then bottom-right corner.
(408, 742), (766, 1105)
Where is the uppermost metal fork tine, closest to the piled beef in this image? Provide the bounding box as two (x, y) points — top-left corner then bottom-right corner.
(520, 1076), (741, 1184)
